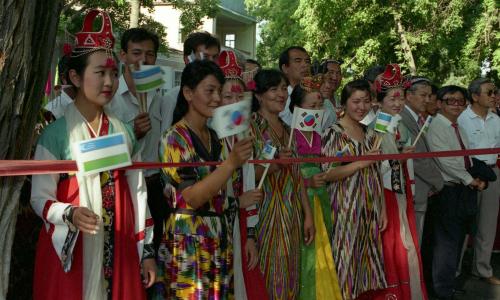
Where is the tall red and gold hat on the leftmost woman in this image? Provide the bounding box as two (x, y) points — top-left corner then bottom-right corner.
(71, 9), (115, 58)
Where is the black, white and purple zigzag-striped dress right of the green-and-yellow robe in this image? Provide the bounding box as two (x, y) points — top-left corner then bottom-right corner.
(321, 123), (386, 299)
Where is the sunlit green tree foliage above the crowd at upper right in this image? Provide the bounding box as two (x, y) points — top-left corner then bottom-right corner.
(246, 0), (500, 84)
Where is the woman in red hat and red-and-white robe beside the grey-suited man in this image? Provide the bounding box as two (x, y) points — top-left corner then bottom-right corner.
(375, 64), (427, 300)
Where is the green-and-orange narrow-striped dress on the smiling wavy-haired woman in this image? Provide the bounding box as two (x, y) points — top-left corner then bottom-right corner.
(251, 113), (302, 299)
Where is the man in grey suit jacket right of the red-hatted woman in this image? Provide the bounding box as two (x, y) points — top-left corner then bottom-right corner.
(400, 77), (443, 244)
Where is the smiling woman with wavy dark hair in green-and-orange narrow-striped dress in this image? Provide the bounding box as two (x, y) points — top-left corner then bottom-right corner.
(252, 70), (314, 299)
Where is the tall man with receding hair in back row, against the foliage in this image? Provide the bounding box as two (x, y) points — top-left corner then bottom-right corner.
(278, 46), (311, 126)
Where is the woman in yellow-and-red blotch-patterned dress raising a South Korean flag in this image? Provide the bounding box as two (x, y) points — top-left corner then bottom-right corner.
(160, 61), (252, 299)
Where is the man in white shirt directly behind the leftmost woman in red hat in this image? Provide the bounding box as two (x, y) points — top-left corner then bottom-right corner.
(108, 28), (167, 251)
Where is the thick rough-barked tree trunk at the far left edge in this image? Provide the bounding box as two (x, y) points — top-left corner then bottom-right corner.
(0, 0), (62, 299)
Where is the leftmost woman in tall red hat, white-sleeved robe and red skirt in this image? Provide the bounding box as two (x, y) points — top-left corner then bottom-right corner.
(31, 10), (155, 300)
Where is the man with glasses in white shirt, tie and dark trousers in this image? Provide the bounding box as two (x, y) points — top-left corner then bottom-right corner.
(427, 86), (485, 299)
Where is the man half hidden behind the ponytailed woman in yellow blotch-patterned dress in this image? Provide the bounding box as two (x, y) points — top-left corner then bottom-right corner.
(160, 31), (220, 134)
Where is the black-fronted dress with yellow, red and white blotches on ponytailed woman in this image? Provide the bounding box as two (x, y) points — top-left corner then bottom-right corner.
(159, 120), (233, 299)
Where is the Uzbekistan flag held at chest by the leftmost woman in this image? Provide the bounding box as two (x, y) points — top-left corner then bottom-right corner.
(73, 133), (132, 175)
